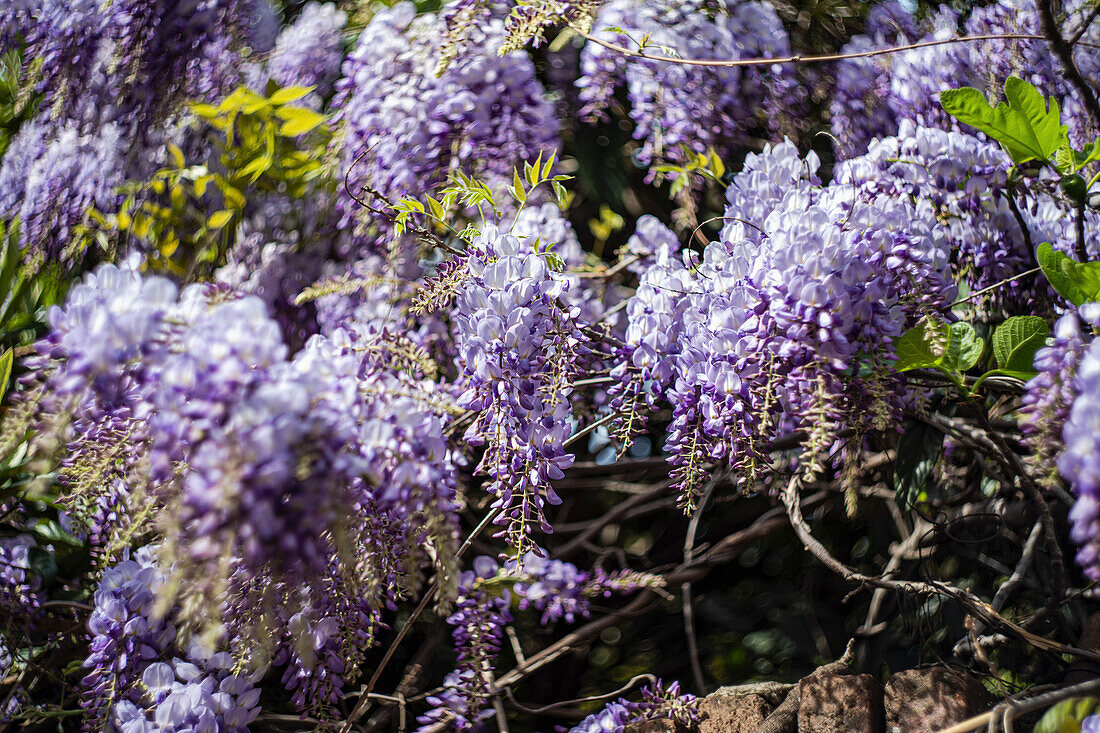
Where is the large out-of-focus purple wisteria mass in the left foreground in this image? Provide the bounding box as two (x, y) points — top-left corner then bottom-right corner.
(46, 266), (457, 702)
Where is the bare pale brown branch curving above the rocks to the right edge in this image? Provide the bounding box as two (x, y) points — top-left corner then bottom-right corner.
(781, 475), (1100, 661)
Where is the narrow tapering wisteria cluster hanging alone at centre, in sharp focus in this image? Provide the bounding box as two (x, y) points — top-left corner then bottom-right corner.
(454, 226), (585, 551)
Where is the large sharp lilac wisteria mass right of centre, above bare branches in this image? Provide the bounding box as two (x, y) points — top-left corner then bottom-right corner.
(618, 145), (954, 505)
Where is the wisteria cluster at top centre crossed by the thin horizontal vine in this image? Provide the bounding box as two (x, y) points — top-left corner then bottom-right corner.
(578, 0), (802, 170)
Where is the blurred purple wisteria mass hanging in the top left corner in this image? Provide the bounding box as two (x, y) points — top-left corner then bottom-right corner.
(0, 0), (274, 265)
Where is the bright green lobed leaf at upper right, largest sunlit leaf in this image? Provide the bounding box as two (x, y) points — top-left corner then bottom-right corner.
(939, 76), (1069, 164)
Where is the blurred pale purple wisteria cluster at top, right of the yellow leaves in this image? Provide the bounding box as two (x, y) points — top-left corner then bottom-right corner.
(333, 2), (559, 254)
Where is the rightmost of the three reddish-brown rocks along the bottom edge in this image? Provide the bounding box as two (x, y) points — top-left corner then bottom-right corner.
(886, 667), (990, 733)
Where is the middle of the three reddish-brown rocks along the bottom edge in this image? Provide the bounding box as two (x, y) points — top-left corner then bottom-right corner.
(799, 672), (883, 733)
